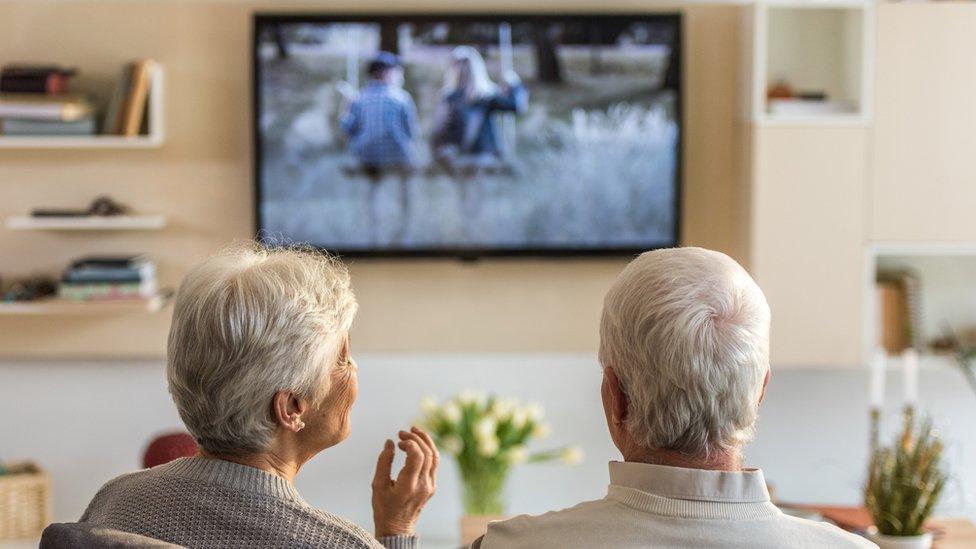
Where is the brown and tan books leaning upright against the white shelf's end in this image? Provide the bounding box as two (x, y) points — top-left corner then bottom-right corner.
(103, 59), (158, 136)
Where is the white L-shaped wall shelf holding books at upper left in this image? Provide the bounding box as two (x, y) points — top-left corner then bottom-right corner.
(0, 66), (166, 149)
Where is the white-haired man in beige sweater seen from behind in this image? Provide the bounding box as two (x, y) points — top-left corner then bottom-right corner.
(474, 248), (874, 549)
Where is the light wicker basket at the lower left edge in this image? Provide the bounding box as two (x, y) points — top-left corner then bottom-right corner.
(0, 463), (51, 539)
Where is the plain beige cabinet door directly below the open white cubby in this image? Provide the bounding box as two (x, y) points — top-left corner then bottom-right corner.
(751, 127), (867, 366)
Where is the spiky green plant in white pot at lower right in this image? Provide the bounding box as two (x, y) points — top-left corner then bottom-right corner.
(864, 409), (947, 549)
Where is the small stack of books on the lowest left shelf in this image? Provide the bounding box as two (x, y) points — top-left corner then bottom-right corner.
(58, 255), (157, 301)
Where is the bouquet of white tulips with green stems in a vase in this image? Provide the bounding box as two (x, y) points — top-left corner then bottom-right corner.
(421, 391), (583, 515)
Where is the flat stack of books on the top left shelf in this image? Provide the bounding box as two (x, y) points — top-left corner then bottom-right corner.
(0, 65), (97, 136)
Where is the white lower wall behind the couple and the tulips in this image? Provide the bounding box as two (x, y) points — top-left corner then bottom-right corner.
(0, 354), (976, 540)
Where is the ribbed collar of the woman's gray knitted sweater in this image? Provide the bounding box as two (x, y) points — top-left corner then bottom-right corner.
(151, 457), (304, 503)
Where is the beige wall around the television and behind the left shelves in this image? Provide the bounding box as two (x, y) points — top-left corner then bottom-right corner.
(0, 0), (744, 358)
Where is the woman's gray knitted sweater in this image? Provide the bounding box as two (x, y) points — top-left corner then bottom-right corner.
(81, 458), (418, 549)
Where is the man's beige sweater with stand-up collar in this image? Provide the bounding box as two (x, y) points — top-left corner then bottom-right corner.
(476, 462), (876, 549)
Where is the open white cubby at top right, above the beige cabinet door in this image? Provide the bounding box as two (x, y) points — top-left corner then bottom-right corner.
(743, 0), (874, 126)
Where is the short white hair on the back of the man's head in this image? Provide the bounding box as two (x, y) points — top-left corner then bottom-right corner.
(600, 248), (770, 456)
